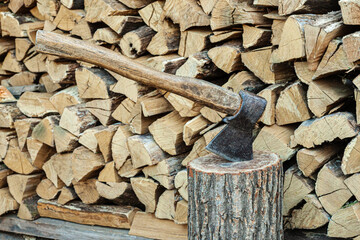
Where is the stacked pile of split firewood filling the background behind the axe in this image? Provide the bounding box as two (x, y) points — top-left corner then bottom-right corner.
(0, 0), (360, 239)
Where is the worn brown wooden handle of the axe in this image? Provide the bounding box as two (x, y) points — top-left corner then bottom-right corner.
(36, 31), (242, 115)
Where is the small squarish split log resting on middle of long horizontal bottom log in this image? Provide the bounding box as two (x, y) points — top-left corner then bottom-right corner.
(74, 178), (102, 204)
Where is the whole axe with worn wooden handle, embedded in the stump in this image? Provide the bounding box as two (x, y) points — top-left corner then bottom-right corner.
(36, 31), (266, 162)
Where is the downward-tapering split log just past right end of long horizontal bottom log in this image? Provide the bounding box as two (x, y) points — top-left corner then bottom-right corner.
(130, 177), (163, 213)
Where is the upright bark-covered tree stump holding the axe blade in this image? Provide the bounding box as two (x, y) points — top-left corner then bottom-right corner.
(188, 152), (283, 240)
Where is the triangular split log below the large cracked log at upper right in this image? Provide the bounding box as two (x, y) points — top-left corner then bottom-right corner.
(313, 39), (355, 79)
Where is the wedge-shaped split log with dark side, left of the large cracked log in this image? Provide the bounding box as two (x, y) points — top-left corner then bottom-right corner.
(241, 47), (294, 84)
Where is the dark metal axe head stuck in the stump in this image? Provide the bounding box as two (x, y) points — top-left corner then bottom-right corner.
(206, 91), (266, 162)
